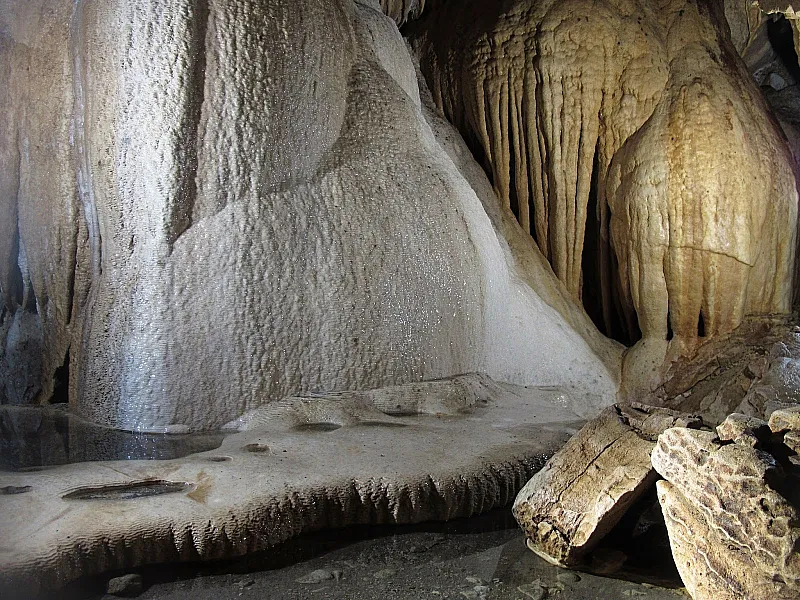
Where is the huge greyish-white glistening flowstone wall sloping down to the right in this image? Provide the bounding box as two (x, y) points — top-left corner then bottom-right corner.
(0, 0), (621, 431)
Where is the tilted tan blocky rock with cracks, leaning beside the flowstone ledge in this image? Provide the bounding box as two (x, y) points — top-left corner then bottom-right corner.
(513, 404), (702, 566)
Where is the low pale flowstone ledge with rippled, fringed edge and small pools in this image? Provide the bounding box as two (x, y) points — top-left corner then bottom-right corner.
(0, 375), (580, 598)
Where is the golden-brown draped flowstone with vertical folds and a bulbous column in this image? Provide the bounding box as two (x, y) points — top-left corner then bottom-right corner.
(410, 0), (797, 368)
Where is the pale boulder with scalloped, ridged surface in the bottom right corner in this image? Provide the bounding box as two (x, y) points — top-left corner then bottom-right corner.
(652, 428), (800, 600)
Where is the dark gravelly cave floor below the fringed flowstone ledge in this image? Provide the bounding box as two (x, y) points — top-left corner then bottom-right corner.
(48, 510), (686, 600)
